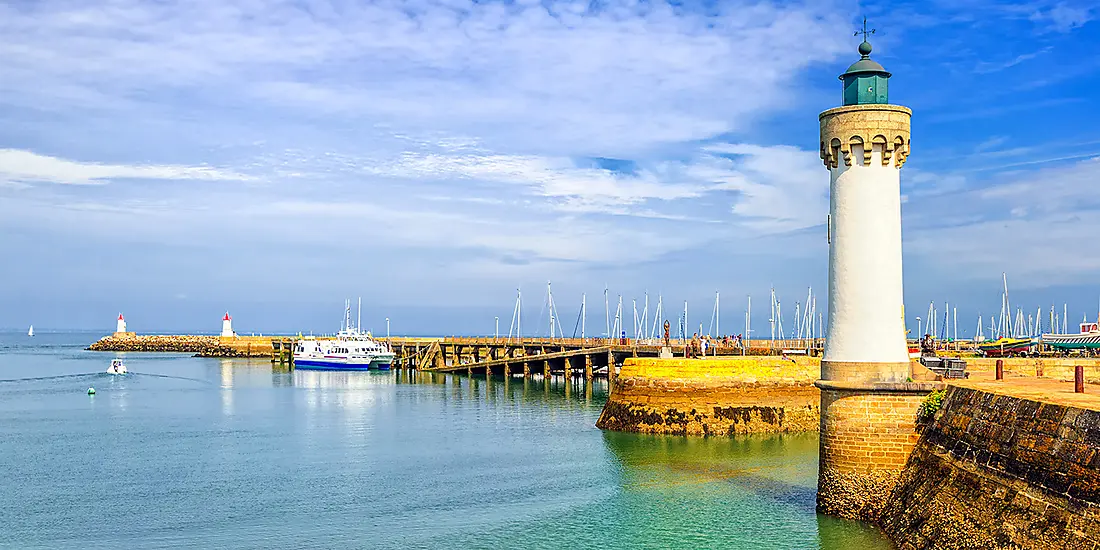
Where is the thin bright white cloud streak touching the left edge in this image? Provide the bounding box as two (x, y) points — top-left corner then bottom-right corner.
(0, 149), (251, 185)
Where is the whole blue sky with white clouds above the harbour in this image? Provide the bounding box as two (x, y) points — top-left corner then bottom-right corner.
(0, 0), (1100, 336)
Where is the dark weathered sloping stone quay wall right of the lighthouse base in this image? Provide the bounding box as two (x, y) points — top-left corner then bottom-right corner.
(880, 383), (1100, 550)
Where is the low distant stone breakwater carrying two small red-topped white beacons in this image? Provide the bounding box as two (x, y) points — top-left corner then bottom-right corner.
(88, 332), (272, 358)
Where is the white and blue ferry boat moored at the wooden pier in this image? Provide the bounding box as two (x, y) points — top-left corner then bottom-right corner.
(294, 303), (394, 371)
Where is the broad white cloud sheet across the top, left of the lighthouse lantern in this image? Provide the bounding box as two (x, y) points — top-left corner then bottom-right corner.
(0, 0), (850, 155)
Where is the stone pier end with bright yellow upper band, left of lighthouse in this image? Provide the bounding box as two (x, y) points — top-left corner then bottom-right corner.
(596, 356), (821, 437)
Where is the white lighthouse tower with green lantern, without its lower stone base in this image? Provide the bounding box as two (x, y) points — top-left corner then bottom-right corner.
(818, 35), (912, 382)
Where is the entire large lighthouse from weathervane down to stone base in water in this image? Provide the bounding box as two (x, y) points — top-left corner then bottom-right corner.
(816, 24), (942, 521)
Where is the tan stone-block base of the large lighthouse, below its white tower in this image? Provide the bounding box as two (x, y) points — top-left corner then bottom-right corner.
(815, 378), (943, 521)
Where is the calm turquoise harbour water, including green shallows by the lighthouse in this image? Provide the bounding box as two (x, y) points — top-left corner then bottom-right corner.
(0, 333), (889, 549)
